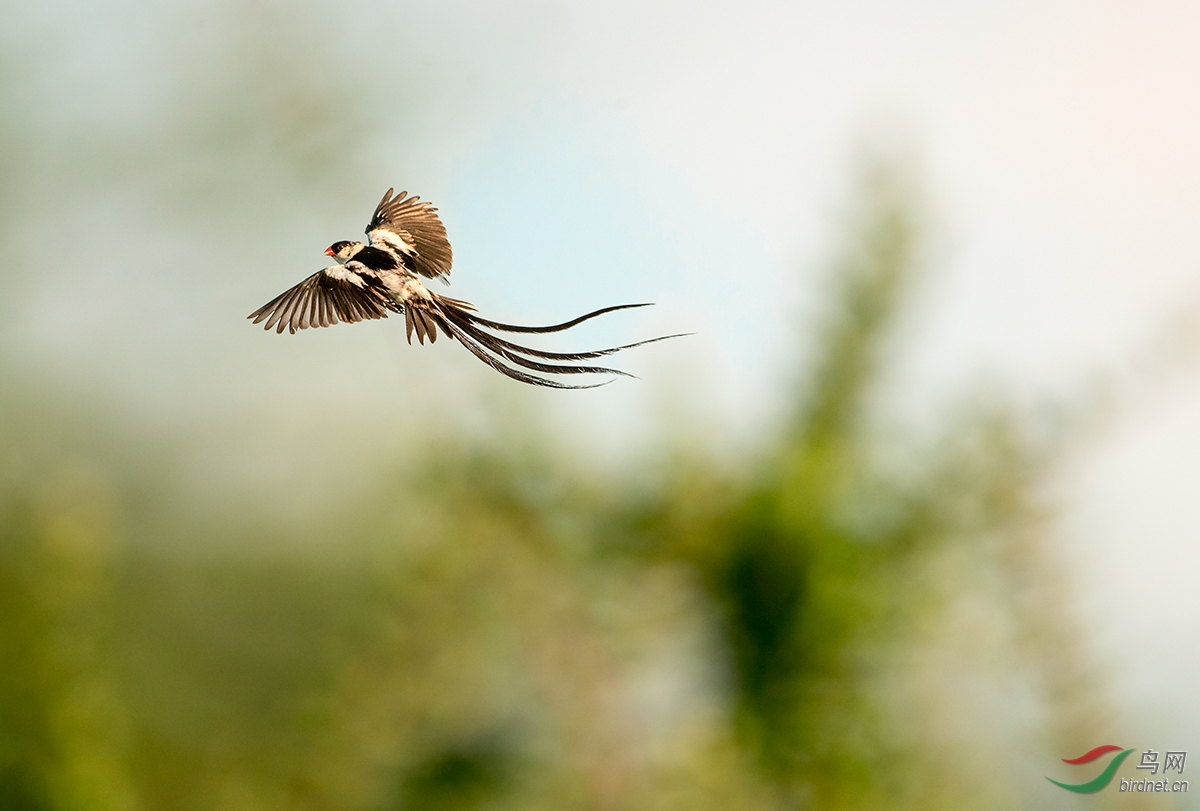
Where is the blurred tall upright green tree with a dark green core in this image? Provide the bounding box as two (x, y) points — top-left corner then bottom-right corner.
(624, 163), (937, 807)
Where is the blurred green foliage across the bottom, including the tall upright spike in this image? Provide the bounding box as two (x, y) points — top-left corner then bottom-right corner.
(0, 158), (1123, 811)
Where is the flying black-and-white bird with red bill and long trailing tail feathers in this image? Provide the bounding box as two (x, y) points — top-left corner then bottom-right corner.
(247, 188), (680, 389)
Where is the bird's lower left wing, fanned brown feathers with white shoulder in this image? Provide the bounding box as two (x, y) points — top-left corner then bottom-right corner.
(247, 265), (398, 334)
